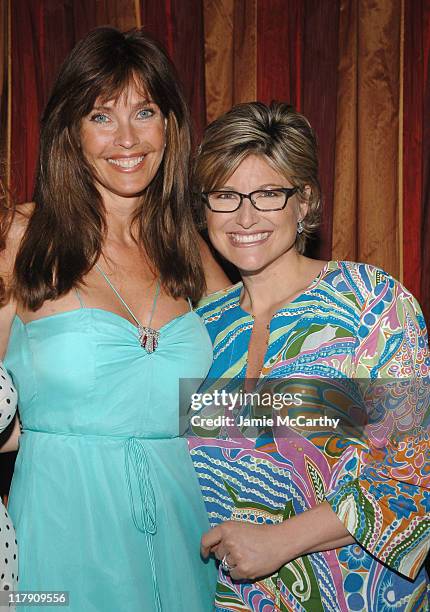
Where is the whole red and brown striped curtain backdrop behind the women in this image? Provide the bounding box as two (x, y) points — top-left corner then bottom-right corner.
(0, 0), (430, 317)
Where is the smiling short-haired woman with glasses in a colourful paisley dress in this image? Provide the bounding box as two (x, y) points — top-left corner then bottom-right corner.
(189, 102), (430, 612)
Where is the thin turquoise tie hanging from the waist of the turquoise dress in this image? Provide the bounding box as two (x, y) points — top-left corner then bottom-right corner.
(125, 438), (162, 612)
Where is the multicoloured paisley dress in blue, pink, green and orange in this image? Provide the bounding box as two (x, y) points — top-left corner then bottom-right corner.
(189, 261), (430, 612)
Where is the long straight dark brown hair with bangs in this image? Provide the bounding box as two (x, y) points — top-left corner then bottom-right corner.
(15, 27), (204, 310)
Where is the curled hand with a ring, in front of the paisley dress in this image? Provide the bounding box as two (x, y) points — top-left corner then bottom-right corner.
(201, 521), (289, 580)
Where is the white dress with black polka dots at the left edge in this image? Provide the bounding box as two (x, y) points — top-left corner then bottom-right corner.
(0, 362), (18, 591)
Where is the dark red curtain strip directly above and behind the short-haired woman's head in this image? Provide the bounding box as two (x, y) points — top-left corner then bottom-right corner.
(257, 0), (339, 259)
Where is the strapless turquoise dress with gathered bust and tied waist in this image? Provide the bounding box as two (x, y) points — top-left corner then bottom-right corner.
(5, 307), (216, 612)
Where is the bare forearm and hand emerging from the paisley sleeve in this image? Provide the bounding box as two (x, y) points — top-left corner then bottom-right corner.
(201, 502), (355, 580)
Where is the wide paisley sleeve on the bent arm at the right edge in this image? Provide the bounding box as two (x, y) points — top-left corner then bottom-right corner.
(326, 271), (430, 579)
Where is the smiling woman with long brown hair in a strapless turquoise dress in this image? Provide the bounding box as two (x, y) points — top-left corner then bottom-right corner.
(2, 28), (225, 612)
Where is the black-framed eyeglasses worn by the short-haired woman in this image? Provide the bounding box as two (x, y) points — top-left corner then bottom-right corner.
(202, 187), (297, 212)
